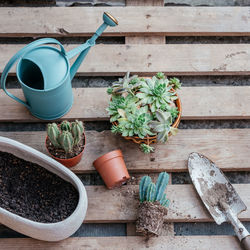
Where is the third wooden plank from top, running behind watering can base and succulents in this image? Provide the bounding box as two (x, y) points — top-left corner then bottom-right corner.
(0, 86), (250, 122)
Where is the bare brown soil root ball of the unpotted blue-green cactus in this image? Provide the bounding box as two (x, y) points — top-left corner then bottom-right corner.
(136, 201), (168, 238)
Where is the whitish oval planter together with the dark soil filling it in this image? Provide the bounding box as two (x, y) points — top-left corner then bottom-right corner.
(0, 137), (88, 241)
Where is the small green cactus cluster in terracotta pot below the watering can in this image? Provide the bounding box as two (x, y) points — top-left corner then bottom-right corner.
(45, 120), (86, 167)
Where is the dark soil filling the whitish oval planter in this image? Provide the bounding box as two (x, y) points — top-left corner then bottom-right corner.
(0, 151), (79, 223)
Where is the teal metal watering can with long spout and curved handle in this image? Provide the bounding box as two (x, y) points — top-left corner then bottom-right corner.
(1, 13), (118, 120)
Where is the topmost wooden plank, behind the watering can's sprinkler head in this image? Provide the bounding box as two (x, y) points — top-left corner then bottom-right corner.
(0, 6), (250, 37)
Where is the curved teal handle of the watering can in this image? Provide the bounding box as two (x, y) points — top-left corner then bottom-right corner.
(1, 38), (66, 108)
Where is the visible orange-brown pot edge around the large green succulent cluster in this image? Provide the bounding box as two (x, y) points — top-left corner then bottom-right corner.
(112, 91), (182, 145)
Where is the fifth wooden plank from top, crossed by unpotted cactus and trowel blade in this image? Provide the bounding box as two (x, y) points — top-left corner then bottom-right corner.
(85, 184), (250, 223)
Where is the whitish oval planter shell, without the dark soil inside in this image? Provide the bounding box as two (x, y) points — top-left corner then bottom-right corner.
(0, 136), (88, 241)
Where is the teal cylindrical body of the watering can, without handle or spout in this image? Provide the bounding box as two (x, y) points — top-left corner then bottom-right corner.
(16, 42), (73, 120)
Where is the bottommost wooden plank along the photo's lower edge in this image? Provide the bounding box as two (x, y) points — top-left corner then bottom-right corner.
(0, 235), (241, 250)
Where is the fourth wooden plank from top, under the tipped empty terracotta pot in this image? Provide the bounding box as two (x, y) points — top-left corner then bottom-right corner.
(0, 129), (250, 173)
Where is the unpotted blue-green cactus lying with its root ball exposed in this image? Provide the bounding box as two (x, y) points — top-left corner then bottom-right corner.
(136, 172), (170, 237)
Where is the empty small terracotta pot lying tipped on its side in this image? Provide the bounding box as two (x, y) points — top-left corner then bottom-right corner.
(93, 150), (130, 189)
